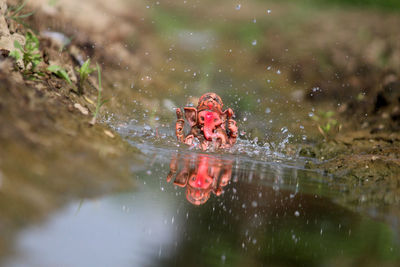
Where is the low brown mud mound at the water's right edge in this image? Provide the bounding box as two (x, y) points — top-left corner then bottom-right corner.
(300, 130), (400, 207)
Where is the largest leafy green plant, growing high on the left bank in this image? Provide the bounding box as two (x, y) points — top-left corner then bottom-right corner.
(10, 31), (43, 74)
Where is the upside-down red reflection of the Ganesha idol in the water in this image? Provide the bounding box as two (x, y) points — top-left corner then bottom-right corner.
(167, 154), (233, 205)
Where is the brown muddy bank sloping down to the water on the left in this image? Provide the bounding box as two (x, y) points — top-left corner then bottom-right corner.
(0, 1), (148, 260)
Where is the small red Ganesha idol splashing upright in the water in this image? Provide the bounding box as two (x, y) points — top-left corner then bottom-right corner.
(175, 93), (238, 150)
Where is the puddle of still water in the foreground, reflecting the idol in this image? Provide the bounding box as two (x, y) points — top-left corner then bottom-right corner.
(5, 132), (400, 266)
